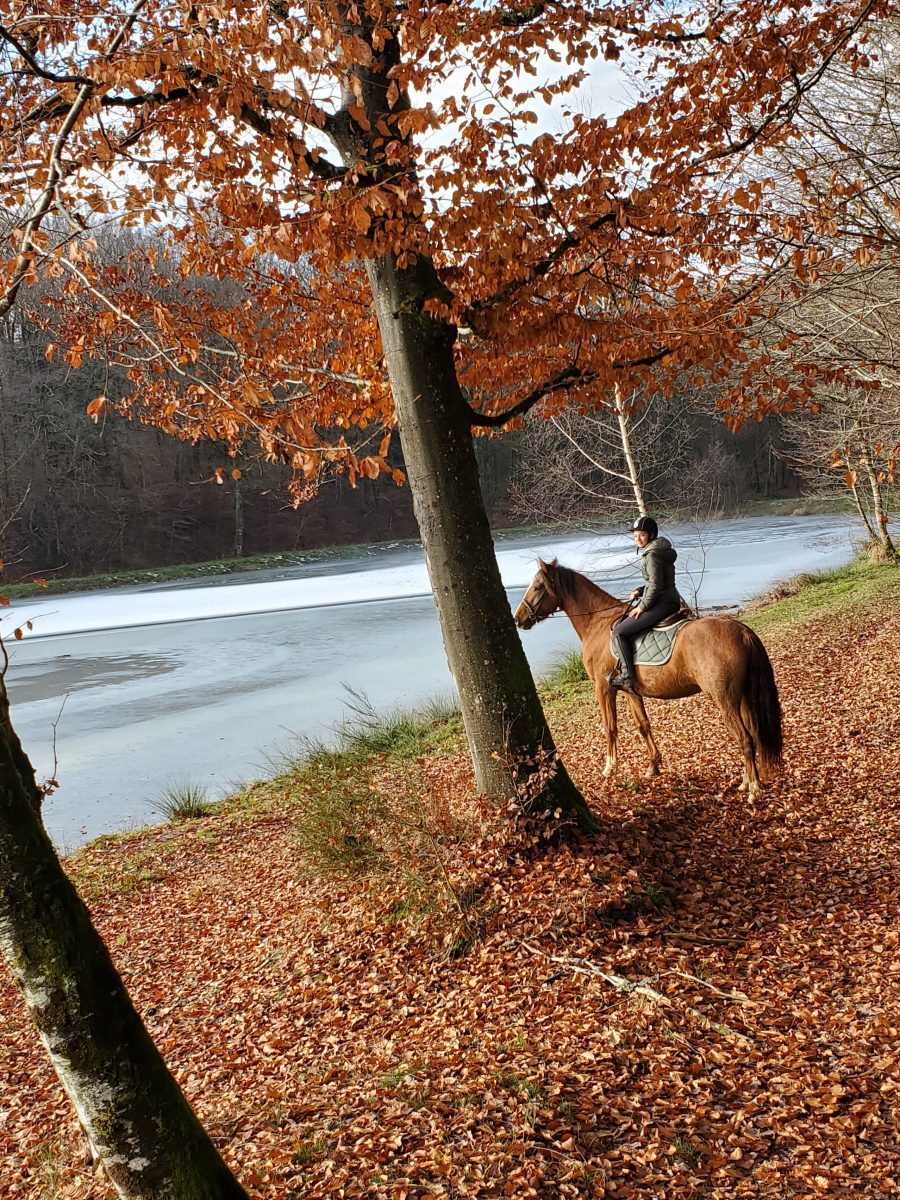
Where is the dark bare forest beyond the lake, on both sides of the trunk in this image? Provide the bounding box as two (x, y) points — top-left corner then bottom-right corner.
(0, 290), (799, 577)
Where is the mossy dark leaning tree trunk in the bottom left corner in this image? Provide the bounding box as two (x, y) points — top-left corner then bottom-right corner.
(0, 696), (247, 1200)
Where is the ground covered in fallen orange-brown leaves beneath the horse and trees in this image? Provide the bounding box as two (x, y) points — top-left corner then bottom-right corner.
(0, 566), (900, 1200)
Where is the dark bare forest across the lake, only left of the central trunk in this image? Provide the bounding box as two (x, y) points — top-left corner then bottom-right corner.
(0, 306), (415, 578)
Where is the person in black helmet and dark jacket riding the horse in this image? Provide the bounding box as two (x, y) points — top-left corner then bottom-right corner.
(606, 517), (682, 691)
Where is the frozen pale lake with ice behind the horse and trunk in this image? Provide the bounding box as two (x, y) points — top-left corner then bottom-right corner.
(1, 517), (853, 850)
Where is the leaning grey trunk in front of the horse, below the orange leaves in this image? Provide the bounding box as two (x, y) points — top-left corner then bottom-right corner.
(366, 257), (594, 829)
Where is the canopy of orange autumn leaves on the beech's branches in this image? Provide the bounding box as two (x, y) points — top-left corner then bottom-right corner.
(0, 0), (892, 492)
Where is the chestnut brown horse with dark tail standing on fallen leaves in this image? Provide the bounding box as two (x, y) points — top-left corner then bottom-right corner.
(515, 559), (781, 799)
